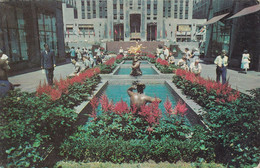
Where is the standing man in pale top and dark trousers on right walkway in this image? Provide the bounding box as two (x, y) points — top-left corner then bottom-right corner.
(214, 50), (228, 84)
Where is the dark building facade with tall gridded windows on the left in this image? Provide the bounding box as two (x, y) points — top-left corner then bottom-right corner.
(0, 0), (69, 71)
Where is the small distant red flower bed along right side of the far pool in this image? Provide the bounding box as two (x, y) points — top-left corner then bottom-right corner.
(155, 58), (179, 73)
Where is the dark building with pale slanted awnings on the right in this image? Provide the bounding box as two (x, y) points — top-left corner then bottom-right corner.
(193, 0), (260, 71)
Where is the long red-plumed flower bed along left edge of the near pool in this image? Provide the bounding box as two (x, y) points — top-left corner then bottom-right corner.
(0, 68), (100, 167)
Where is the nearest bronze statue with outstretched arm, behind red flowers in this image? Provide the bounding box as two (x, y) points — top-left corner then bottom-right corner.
(127, 82), (162, 111)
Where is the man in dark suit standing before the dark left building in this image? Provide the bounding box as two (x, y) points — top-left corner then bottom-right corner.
(41, 44), (56, 85)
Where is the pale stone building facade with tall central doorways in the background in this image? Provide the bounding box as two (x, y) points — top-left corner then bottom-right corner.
(63, 0), (206, 43)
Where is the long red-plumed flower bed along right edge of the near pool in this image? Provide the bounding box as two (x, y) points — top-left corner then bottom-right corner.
(173, 69), (260, 167)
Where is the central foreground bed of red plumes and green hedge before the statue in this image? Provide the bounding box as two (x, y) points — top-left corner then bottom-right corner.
(61, 96), (214, 163)
